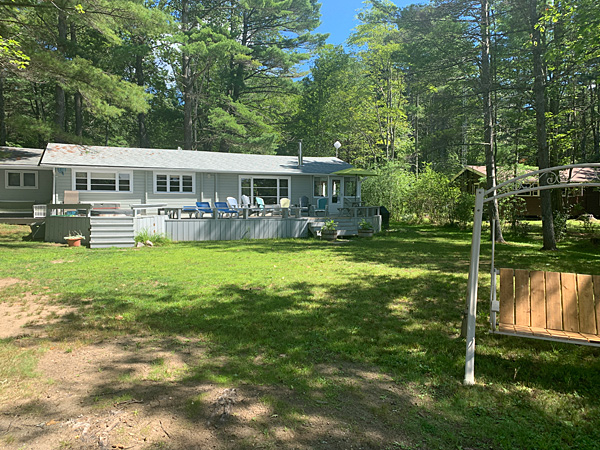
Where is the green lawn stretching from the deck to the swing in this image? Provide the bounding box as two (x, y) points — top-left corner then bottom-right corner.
(0, 224), (600, 449)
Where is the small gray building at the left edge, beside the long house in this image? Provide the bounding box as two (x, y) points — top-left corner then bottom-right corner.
(0, 147), (52, 217)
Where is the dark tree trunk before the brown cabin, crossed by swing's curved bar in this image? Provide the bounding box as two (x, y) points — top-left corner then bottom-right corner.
(529, 0), (556, 250)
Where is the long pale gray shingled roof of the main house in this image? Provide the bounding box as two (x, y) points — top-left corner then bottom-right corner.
(40, 144), (352, 175)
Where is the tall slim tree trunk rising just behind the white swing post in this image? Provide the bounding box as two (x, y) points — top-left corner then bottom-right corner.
(481, 0), (504, 242)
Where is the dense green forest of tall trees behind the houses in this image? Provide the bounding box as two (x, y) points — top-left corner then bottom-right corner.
(0, 0), (600, 248)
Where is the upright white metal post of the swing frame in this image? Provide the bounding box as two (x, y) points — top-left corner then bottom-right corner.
(464, 189), (485, 385)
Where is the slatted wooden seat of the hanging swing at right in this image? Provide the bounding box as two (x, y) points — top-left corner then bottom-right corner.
(493, 269), (600, 346)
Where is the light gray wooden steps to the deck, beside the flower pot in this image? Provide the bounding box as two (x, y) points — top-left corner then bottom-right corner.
(90, 216), (135, 248)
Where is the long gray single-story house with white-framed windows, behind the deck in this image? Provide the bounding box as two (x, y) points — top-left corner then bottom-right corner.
(40, 144), (360, 213)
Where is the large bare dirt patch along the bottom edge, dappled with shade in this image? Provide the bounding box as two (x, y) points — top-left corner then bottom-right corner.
(0, 337), (416, 450)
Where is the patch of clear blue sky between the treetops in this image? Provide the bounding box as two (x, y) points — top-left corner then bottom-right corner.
(316, 0), (420, 45)
